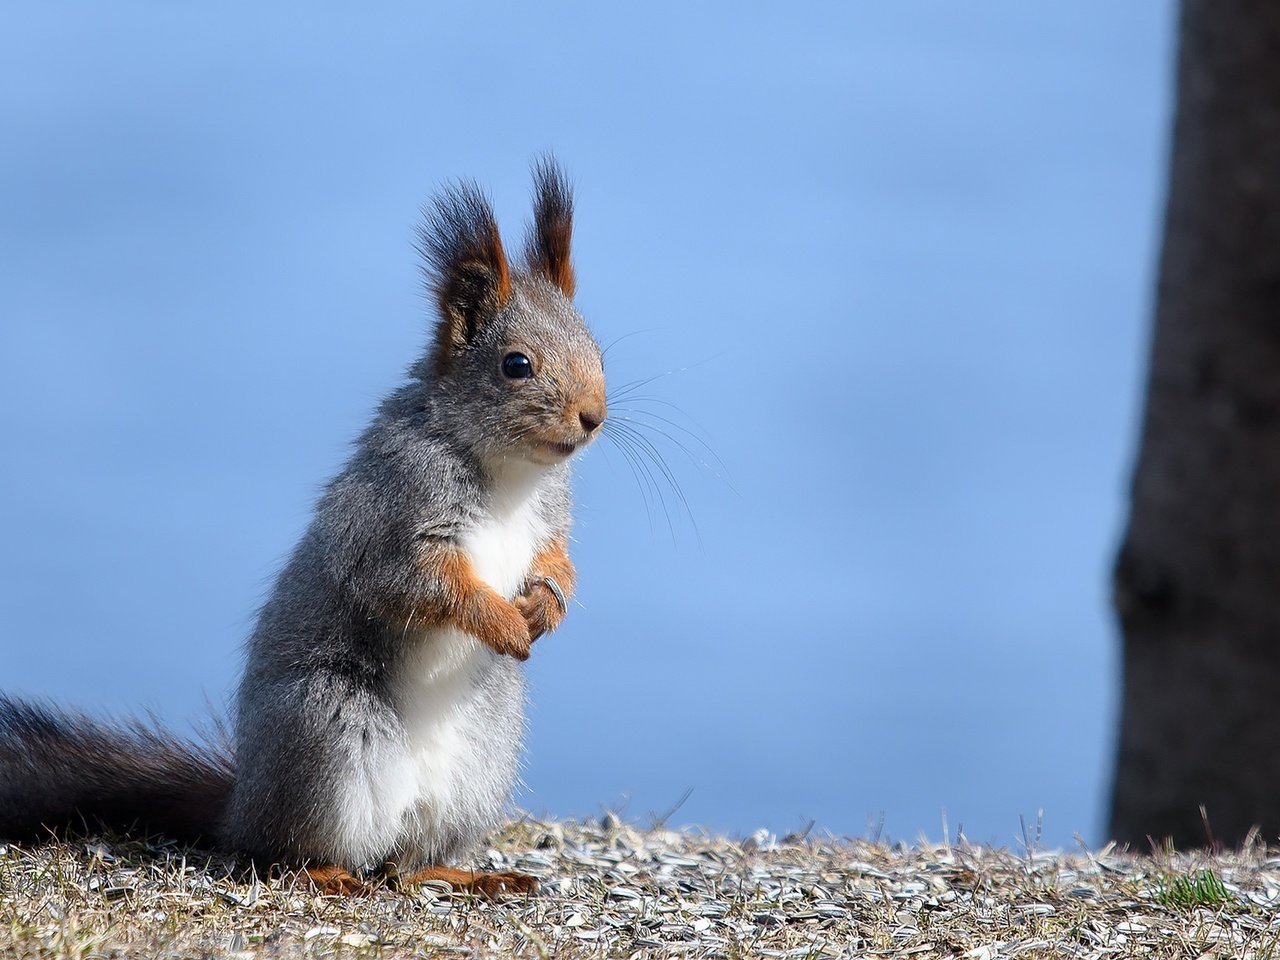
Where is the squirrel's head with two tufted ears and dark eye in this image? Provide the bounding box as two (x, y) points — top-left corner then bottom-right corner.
(419, 159), (605, 466)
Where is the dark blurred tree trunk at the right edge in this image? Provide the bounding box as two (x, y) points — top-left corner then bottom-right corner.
(1111, 0), (1280, 846)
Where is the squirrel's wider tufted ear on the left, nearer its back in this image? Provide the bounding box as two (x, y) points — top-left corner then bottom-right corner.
(417, 183), (511, 362)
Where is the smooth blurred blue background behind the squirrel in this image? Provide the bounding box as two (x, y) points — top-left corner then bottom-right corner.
(0, 0), (1174, 846)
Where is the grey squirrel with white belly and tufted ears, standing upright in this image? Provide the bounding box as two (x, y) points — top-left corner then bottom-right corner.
(0, 157), (607, 895)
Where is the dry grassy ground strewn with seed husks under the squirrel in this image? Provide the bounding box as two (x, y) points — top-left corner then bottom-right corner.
(0, 817), (1280, 960)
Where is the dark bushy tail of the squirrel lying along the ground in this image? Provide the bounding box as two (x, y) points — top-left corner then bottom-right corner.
(0, 696), (234, 845)
